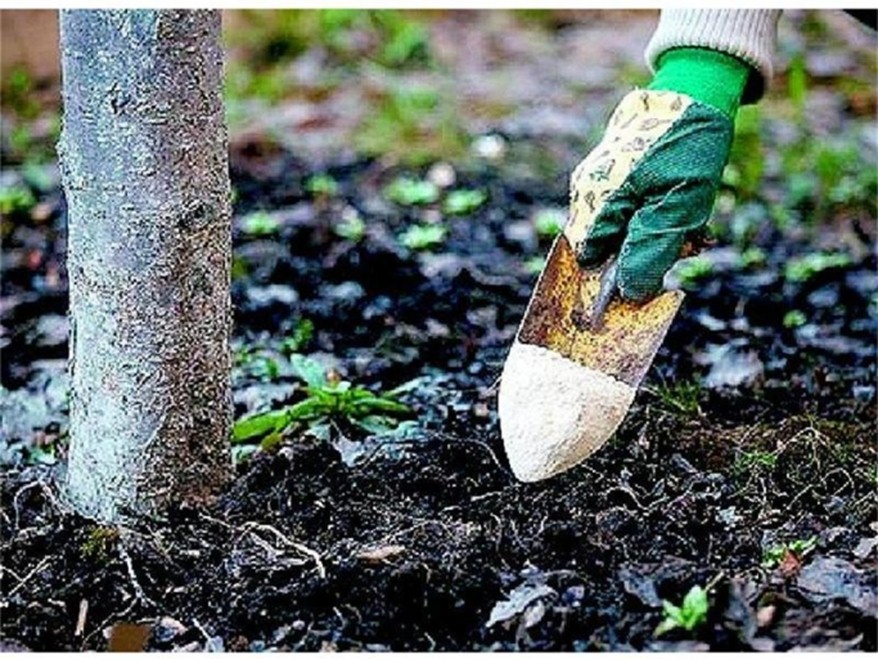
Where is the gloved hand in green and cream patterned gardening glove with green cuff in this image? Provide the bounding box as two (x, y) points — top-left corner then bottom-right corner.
(564, 48), (758, 300)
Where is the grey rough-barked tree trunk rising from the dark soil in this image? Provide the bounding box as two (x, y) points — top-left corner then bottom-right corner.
(58, 10), (232, 522)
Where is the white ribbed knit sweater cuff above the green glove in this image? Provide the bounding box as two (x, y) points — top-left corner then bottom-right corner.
(646, 9), (781, 101)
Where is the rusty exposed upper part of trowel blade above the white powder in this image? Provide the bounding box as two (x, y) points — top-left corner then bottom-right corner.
(517, 234), (683, 388)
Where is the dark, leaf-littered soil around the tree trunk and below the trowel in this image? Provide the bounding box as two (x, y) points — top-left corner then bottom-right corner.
(0, 135), (878, 651)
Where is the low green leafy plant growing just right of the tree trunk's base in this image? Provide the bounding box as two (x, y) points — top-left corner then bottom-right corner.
(232, 355), (409, 448)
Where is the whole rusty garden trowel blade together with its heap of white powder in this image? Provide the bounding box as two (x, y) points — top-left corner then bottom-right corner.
(499, 229), (683, 481)
